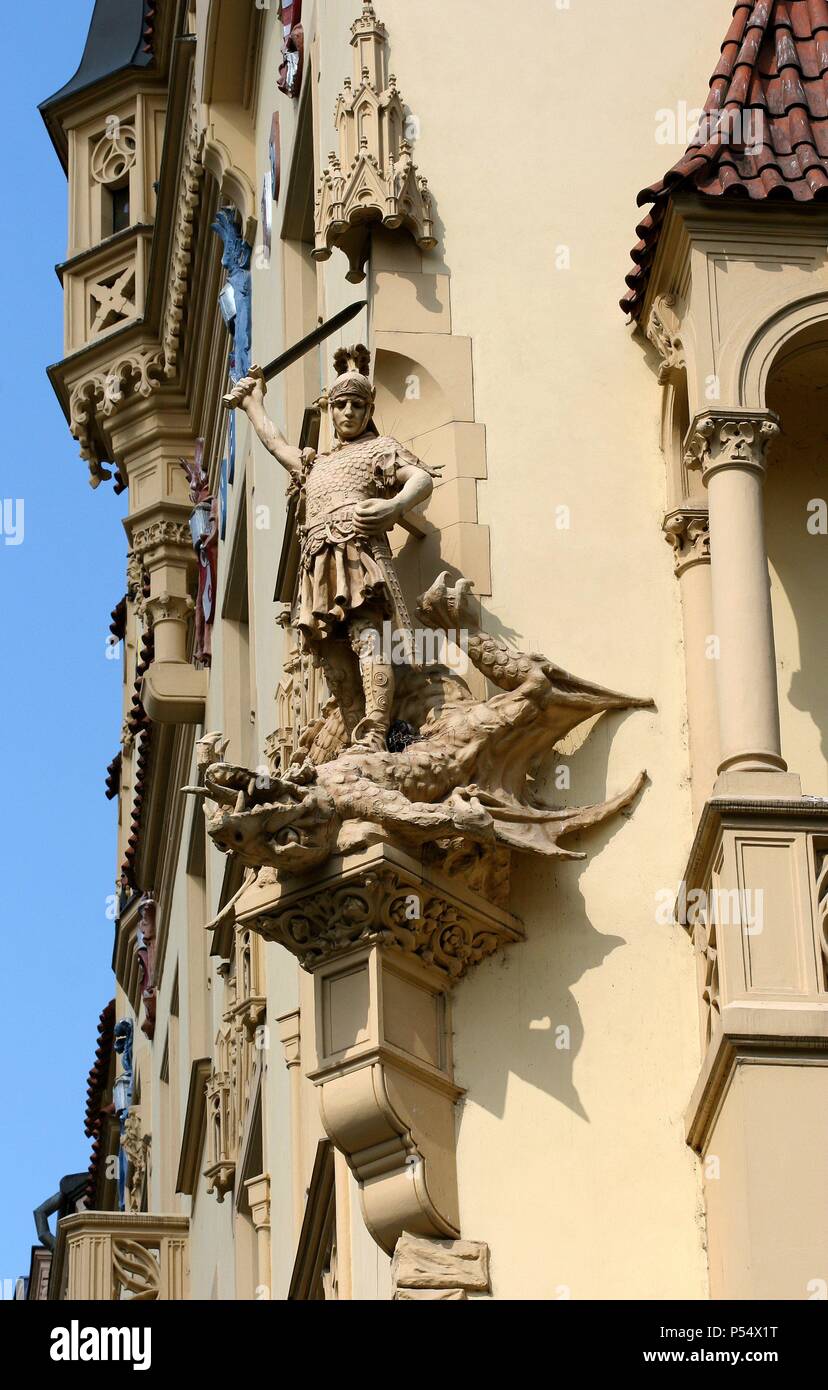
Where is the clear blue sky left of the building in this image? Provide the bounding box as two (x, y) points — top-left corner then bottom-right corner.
(0, 0), (125, 1290)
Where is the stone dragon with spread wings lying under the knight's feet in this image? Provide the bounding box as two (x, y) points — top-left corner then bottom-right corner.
(185, 573), (652, 901)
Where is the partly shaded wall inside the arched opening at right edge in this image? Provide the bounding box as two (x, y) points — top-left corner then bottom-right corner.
(765, 336), (828, 795)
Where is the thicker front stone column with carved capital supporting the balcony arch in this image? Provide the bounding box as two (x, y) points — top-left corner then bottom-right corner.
(686, 410), (792, 796)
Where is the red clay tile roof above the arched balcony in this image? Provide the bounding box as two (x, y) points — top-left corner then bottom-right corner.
(621, 0), (828, 318)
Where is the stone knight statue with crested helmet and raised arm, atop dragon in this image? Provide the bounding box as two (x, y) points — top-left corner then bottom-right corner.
(225, 353), (436, 752)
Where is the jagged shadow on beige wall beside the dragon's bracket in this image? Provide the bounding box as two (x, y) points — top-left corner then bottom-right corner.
(456, 713), (646, 1125)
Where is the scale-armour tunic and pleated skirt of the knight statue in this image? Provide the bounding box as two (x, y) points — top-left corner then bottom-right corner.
(296, 435), (424, 644)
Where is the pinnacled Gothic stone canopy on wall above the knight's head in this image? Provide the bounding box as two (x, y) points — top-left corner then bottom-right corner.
(313, 3), (436, 284)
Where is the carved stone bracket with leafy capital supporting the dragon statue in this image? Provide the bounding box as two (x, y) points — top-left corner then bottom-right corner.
(229, 845), (524, 1254)
